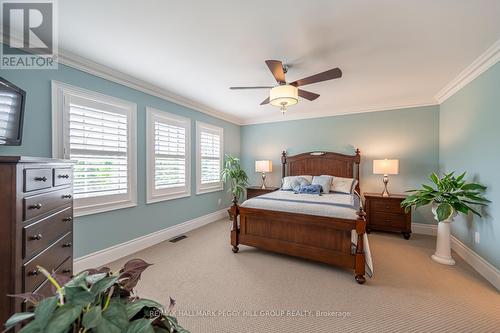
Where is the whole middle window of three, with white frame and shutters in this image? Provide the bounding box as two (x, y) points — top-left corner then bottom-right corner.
(146, 108), (191, 203)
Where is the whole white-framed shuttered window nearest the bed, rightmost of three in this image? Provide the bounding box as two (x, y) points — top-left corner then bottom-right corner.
(196, 121), (224, 194)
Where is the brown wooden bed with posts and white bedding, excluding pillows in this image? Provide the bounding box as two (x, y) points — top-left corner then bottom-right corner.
(231, 149), (373, 284)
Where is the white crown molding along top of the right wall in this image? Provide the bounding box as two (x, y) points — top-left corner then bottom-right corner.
(435, 39), (500, 104)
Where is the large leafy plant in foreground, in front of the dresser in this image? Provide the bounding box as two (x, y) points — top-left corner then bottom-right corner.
(5, 259), (189, 333)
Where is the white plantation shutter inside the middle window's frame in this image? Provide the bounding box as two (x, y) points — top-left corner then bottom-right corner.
(154, 121), (186, 190)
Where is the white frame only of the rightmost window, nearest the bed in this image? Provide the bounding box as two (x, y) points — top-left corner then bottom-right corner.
(196, 121), (224, 195)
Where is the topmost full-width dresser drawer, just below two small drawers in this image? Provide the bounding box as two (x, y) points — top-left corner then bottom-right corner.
(23, 188), (73, 221)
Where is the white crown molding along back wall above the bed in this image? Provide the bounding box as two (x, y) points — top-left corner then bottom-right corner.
(240, 100), (438, 126)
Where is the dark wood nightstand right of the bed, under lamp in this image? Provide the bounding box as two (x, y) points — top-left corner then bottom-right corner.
(364, 193), (411, 239)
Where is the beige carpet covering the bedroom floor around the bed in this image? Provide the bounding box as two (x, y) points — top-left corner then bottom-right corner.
(110, 221), (500, 333)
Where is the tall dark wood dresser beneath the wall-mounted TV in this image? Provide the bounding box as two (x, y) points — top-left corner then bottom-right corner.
(0, 156), (73, 323)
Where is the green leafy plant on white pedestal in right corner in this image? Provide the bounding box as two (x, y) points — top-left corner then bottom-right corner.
(401, 172), (490, 265)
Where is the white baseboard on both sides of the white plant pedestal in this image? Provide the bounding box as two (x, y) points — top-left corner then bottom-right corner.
(412, 223), (500, 290)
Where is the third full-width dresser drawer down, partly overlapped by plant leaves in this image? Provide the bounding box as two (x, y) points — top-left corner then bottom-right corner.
(23, 233), (73, 291)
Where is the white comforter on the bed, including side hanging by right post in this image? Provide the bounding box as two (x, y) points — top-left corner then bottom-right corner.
(241, 191), (373, 277)
